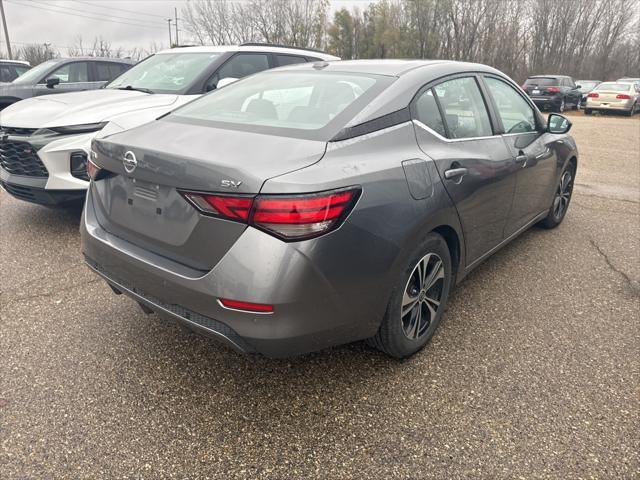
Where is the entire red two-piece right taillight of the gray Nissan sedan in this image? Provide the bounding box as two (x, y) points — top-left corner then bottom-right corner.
(181, 188), (361, 241)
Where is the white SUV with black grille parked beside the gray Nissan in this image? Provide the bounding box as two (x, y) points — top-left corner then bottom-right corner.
(0, 45), (337, 205)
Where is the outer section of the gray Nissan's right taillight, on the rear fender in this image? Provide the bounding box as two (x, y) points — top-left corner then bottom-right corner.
(251, 188), (360, 240)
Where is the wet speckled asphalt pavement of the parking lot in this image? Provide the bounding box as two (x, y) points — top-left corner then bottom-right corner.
(0, 114), (640, 479)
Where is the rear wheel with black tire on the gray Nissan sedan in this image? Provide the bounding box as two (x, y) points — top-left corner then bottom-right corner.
(367, 232), (452, 358)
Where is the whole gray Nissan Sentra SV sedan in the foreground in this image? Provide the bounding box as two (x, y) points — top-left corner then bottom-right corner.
(81, 60), (578, 357)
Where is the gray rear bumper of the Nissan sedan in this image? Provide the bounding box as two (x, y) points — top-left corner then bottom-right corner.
(80, 190), (388, 358)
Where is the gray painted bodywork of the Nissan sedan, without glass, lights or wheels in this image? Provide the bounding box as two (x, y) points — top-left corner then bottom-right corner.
(81, 62), (577, 357)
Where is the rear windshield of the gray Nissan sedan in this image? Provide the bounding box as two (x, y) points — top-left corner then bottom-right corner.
(172, 70), (393, 139)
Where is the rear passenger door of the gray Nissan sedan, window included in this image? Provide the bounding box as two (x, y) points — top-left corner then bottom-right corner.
(411, 74), (516, 265)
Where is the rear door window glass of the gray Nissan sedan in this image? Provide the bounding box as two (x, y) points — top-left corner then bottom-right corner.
(433, 77), (493, 138)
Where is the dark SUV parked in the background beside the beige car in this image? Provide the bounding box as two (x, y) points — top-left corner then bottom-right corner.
(522, 75), (582, 112)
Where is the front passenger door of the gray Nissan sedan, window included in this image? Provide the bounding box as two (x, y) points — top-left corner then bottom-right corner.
(483, 75), (557, 237)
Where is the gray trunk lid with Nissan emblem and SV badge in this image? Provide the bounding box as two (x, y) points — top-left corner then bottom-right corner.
(91, 120), (326, 270)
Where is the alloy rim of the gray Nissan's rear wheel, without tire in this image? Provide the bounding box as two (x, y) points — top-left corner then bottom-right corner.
(400, 253), (445, 340)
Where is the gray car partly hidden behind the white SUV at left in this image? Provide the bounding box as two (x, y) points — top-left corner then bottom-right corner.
(0, 57), (134, 110)
